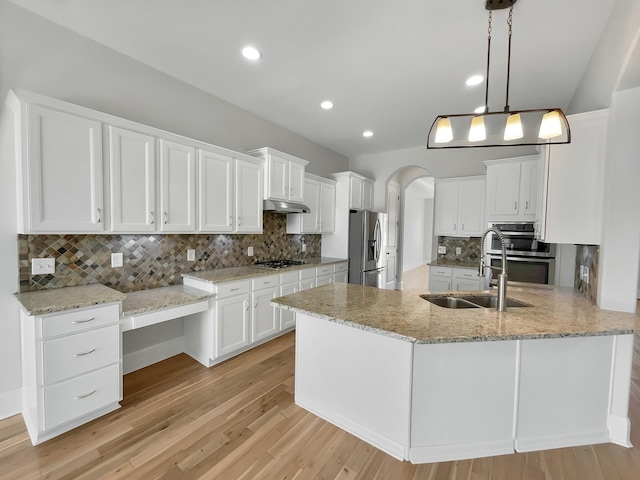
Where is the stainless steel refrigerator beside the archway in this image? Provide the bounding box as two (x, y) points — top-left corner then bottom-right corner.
(349, 211), (387, 288)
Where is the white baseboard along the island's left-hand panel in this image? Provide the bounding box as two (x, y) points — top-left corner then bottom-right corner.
(295, 395), (408, 460)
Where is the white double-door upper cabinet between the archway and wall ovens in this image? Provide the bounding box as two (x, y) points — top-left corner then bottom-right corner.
(435, 177), (486, 237)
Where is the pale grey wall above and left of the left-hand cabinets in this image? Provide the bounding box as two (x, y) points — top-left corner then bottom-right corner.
(0, 0), (348, 418)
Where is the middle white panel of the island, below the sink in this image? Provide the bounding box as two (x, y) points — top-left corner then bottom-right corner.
(410, 341), (518, 463)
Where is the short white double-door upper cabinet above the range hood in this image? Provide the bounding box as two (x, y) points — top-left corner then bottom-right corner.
(247, 147), (309, 203)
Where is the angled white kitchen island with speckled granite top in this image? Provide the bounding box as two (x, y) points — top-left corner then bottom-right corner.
(273, 284), (636, 463)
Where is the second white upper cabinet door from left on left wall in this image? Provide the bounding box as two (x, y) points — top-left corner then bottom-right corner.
(108, 126), (160, 232)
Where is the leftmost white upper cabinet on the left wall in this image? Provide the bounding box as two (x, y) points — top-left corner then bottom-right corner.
(10, 96), (104, 233)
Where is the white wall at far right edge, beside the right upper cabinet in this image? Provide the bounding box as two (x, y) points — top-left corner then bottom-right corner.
(598, 87), (640, 312)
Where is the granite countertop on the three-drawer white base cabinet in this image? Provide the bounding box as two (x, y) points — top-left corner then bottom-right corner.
(15, 283), (127, 316)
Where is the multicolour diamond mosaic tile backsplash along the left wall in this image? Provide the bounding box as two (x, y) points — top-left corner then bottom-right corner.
(18, 212), (322, 292)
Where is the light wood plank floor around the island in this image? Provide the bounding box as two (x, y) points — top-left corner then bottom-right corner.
(0, 306), (640, 480)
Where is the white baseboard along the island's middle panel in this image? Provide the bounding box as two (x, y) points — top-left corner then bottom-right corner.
(409, 438), (514, 464)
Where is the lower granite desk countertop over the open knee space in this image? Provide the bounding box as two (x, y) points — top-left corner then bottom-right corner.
(122, 285), (213, 317)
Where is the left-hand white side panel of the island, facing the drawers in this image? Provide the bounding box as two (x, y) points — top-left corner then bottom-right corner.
(295, 313), (413, 460)
